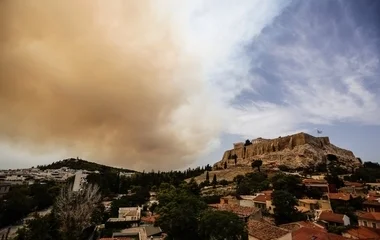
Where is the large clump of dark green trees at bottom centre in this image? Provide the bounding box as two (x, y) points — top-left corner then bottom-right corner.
(156, 184), (246, 240)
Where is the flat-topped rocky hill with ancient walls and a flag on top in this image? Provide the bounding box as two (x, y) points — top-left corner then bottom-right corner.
(214, 132), (360, 169)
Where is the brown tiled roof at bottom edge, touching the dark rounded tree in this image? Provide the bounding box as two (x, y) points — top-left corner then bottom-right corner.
(247, 220), (289, 240)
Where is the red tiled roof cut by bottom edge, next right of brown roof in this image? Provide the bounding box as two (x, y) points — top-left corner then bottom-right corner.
(292, 227), (348, 240)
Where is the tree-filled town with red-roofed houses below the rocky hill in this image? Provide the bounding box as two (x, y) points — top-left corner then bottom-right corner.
(0, 140), (380, 240)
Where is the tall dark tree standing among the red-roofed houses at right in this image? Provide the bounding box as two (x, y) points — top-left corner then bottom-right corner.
(272, 190), (305, 225)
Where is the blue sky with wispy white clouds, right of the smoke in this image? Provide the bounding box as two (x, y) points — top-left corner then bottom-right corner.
(194, 0), (380, 167)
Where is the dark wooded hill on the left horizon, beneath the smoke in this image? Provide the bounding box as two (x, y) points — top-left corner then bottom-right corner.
(37, 158), (136, 172)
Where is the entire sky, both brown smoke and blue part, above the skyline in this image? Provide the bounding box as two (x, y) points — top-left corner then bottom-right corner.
(0, 0), (380, 170)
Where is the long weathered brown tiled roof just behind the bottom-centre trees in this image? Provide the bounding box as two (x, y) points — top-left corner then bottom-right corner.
(209, 204), (262, 222)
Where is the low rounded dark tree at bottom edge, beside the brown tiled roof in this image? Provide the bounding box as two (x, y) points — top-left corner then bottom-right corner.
(199, 211), (247, 240)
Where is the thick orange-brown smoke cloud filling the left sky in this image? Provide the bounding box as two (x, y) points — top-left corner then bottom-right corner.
(0, 0), (211, 169)
